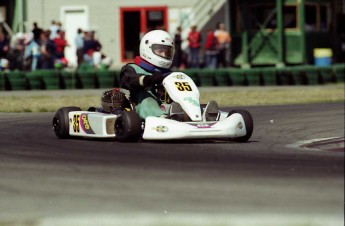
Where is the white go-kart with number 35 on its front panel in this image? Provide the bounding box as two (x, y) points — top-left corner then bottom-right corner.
(53, 72), (253, 142)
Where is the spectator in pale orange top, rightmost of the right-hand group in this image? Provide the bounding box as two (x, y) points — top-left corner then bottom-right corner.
(214, 23), (231, 67)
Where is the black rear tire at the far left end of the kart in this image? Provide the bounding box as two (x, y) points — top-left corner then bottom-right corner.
(53, 107), (81, 139)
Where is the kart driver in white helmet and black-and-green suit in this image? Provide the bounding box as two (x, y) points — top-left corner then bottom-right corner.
(120, 30), (174, 119)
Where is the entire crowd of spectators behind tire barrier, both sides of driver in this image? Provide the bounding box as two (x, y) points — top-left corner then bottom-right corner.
(0, 20), (231, 71)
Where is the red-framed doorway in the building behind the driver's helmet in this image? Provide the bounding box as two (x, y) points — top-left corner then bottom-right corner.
(120, 6), (168, 62)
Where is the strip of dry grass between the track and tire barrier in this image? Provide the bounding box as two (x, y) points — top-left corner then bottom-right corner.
(0, 84), (345, 112)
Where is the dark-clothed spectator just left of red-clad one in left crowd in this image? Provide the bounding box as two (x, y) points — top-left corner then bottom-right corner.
(40, 30), (56, 69)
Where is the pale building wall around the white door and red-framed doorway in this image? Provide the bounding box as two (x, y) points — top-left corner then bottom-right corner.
(27, 0), (197, 68)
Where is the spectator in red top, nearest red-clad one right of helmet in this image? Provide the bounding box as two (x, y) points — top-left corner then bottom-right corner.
(188, 25), (201, 68)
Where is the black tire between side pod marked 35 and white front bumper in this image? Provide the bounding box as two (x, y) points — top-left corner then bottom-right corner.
(114, 111), (142, 142)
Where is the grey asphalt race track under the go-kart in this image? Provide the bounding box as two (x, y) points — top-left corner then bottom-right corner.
(0, 103), (344, 226)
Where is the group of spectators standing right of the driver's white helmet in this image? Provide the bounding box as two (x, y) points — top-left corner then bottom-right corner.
(172, 23), (231, 69)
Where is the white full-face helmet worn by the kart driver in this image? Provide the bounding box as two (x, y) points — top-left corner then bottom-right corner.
(139, 30), (174, 69)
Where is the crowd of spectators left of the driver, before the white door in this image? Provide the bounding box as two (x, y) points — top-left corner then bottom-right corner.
(0, 20), (111, 71)
